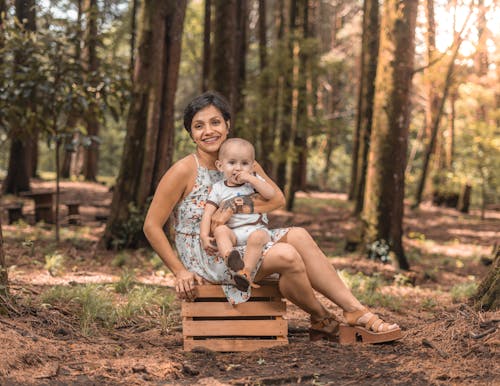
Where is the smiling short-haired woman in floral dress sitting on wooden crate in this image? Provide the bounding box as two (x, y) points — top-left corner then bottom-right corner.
(144, 92), (401, 343)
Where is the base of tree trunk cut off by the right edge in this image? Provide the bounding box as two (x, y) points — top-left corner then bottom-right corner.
(472, 244), (500, 311)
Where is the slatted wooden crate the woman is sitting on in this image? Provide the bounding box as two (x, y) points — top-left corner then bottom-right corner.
(181, 283), (288, 352)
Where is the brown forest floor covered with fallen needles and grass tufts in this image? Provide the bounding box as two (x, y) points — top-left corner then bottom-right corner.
(0, 182), (500, 385)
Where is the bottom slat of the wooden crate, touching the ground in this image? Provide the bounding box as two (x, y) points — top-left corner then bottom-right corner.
(184, 338), (288, 352)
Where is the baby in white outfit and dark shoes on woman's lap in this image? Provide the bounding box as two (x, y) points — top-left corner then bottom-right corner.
(200, 138), (276, 291)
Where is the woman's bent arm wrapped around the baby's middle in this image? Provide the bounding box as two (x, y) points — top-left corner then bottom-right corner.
(210, 162), (285, 231)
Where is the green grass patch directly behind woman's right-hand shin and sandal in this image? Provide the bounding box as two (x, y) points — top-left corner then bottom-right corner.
(339, 270), (402, 311)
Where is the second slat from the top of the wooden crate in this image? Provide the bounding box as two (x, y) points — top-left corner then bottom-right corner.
(182, 301), (286, 317)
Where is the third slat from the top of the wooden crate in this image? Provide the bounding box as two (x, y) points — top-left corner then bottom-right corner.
(182, 319), (288, 336)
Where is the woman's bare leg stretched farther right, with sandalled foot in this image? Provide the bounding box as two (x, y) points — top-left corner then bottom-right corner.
(280, 227), (398, 330)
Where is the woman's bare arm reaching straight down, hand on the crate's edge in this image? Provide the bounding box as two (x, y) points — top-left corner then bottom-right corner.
(143, 159), (202, 298)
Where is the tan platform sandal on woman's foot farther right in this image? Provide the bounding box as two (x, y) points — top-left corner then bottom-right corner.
(339, 308), (403, 344)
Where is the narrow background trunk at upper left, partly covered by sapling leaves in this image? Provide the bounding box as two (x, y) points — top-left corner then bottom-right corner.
(83, 0), (99, 181)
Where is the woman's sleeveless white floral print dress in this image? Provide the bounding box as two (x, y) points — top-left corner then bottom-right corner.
(174, 154), (289, 304)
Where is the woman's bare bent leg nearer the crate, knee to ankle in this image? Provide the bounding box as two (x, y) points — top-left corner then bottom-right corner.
(255, 243), (329, 321)
